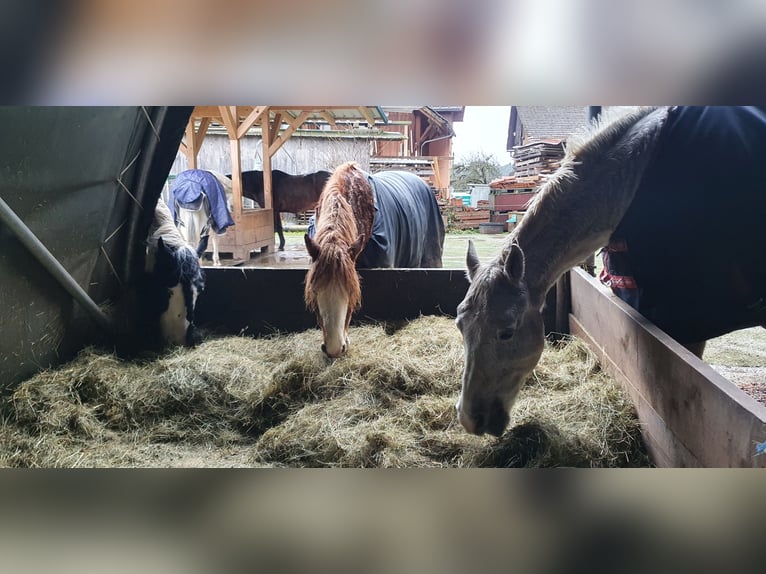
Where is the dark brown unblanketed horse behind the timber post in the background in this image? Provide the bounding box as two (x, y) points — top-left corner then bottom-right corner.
(242, 169), (330, 251)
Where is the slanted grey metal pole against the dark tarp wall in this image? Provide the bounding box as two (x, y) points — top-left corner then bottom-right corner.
(0, 197), (114, 333)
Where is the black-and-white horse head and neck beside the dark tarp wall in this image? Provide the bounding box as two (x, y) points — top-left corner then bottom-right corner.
(139, 200), (205, 346)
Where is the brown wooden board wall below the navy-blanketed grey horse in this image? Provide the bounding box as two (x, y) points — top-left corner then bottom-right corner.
(570, 269), (766, 467)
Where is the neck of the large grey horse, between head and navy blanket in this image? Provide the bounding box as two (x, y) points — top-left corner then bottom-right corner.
(508, 108), (669, 305)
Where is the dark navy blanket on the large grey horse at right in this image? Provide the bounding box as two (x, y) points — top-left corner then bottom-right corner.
(601, 107), (766, 343)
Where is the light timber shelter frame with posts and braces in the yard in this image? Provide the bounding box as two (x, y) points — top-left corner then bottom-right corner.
(181, 106), (388, 259)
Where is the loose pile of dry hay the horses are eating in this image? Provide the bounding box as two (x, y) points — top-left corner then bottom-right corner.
(0, 317), (648, 467)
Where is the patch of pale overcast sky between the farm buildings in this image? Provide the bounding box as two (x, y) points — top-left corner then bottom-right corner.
(452, 106), (511, 165)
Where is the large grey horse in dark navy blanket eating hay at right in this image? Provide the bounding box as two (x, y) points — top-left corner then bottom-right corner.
(456, 107), (766, 436)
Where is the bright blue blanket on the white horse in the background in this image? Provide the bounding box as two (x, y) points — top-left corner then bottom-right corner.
(168, 169), (234, 234)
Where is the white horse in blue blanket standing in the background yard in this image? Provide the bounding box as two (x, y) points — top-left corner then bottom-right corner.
(168, 169), (234, 266)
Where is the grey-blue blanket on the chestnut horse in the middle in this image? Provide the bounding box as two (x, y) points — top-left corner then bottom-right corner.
(356, 171), (444, 268)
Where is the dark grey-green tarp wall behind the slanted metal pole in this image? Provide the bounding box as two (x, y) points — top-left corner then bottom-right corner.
(0, 107), (192, 389)
